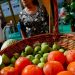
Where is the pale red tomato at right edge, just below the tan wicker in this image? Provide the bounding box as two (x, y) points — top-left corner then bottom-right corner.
(66, 50), (75, 63)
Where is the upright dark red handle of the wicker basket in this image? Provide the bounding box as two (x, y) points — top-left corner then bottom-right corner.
(49, 0), (59, 34)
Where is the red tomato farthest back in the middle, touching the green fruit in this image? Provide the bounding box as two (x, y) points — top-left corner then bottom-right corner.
(48, 51), (66, 64)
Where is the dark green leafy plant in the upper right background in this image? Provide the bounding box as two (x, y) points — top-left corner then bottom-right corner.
(63, 0), (75, 32)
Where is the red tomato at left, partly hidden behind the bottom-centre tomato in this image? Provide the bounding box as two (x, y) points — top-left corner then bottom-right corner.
(15, 57), (32, 75)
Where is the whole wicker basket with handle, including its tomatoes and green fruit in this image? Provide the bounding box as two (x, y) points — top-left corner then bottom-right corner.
(0, 0), (75, 75)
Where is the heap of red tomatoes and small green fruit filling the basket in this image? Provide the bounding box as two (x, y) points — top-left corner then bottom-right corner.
(0, 42), (75, 75)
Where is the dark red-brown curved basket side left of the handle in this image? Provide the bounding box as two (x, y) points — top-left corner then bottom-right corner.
(0, 34), (53, 57)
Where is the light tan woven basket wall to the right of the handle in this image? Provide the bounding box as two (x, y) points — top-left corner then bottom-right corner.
(59, 34), (75, 50)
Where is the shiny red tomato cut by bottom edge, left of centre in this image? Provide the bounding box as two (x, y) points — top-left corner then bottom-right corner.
(21, 65), (44, 75)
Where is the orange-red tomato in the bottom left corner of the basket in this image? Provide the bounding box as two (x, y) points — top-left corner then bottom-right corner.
(0, 66), (17, 75)
